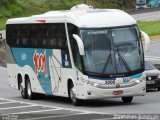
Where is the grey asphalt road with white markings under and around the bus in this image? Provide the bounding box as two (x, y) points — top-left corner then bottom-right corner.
(0, 12), (160, 120)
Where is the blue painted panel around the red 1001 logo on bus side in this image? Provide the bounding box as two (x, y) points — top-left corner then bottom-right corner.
(12, 48), (52, 94)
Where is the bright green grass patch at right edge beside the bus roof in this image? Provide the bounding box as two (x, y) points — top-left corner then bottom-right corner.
(138, 21), (160, 36)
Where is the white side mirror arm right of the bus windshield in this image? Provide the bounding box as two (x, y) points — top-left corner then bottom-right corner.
(141, 31), (151, 52)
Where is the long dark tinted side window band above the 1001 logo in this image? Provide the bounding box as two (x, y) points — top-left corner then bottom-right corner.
(7, 23), (68, 49)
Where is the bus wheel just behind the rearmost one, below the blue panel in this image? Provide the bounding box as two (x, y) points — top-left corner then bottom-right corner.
(27, 80), (35, 100)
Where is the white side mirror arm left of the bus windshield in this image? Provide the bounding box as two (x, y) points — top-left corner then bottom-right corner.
(73, 34), (84, 55)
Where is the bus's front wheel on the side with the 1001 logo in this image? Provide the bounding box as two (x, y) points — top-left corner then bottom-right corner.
(69, 84), (80, 106)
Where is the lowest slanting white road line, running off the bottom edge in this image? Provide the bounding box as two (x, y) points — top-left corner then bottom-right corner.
(19, 113), (88, 120)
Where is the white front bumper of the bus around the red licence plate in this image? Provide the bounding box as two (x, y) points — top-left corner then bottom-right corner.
(80, 80), (146, 99)
